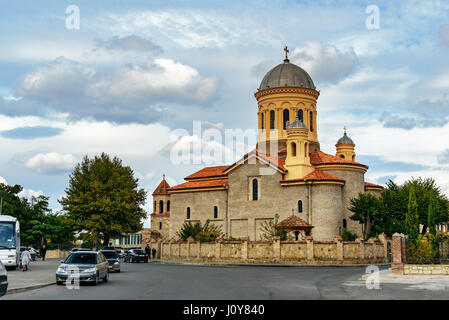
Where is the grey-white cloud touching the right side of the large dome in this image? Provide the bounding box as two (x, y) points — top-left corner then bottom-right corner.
(291, 42), (358, 84)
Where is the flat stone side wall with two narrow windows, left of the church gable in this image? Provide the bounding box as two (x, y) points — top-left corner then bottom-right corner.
(170, 190), (226, 238)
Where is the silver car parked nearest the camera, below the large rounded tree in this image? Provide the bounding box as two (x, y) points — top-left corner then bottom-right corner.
(56, 251), (109, 285)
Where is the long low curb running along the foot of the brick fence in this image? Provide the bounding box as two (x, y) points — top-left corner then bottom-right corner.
(153, 260), (391, 268)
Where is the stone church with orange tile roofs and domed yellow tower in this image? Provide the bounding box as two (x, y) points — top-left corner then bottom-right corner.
(151, 48), (383, 241)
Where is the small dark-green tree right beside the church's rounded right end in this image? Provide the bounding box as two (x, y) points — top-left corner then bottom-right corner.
(349, 193), (383, 239)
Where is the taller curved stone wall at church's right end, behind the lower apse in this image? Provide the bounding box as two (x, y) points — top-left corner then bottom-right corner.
(320, 169), (365, 237)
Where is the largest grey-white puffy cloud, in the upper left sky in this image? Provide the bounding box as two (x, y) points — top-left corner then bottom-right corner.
(16, 57), (218, 122)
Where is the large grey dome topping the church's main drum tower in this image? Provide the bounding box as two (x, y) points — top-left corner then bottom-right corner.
(259, 59), (315, 90)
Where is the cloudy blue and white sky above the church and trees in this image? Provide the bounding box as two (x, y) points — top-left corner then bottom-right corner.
(0, 0), (449, 226)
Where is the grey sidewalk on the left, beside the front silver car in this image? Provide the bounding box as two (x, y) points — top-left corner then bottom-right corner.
(7, 259), (61, 294)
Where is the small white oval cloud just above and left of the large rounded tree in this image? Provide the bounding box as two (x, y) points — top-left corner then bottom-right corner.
(25, 152), (77, 173)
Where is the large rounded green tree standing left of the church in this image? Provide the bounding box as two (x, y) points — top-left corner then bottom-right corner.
(59, 153), (146, 248)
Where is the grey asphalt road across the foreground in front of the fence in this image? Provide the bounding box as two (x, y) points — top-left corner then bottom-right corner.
(0, 263), (449, 300)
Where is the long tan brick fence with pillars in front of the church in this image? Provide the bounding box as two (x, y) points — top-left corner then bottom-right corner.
(142, 235), (388, 264)
